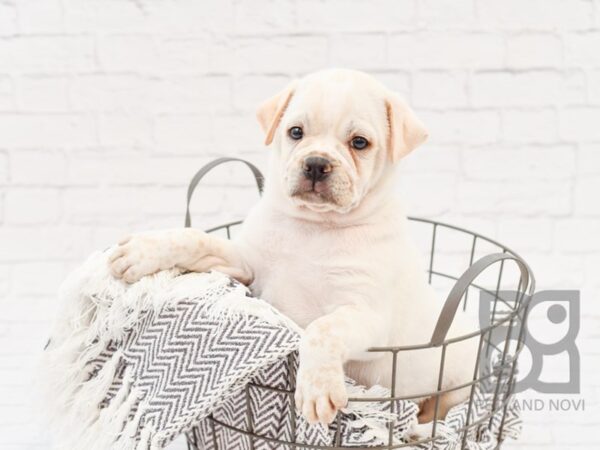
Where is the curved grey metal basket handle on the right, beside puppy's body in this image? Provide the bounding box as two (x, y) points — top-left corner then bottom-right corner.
(430, 253), (530, 347)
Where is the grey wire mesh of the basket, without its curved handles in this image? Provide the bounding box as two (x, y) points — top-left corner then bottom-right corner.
(183, 217), (535, 450)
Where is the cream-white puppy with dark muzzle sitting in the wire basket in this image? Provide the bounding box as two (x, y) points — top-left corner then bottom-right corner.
(111, 70), (475, 424)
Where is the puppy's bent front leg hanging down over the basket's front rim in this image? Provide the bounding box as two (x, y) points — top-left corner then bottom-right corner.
(295, 305), (387, 424)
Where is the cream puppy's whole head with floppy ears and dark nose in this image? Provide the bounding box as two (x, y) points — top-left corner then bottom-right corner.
(258, 70), (426, 213)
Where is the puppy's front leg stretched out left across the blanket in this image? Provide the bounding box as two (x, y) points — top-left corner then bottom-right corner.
(110, 229), (252, 284)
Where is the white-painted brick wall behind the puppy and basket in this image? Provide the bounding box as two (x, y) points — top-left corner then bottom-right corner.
(0, 0), (600, 450)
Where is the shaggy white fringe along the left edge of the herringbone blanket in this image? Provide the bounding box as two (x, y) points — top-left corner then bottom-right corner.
(35, 249), (301, 449)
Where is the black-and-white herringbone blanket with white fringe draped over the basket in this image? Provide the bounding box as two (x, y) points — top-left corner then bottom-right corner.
(38, 250), (520, 450)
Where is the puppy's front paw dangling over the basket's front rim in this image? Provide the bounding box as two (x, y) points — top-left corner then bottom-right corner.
(295, 361), (348, 425)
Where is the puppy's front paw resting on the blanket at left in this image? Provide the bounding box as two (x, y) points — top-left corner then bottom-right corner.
(109, 233), (168, 283)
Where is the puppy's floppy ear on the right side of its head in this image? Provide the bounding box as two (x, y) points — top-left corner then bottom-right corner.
(385, 93), (428, 162)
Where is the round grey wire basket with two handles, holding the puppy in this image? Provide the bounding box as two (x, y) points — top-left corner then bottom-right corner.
(186, 158), (535, 450)
